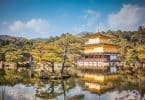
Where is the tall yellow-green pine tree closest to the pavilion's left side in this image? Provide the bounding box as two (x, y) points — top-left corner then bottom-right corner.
(56, 33), (84, 73)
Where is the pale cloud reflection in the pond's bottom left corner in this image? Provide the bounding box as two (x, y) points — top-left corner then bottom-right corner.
(0, 84), (34, 100)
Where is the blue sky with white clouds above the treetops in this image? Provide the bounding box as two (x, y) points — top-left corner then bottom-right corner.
(0, 0), (145, 39)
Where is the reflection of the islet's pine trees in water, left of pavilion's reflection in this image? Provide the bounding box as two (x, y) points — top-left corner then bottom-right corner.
(36, 78), (83, 100)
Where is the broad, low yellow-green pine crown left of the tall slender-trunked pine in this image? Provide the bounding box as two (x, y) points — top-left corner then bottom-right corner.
(31, 43), (62, 62)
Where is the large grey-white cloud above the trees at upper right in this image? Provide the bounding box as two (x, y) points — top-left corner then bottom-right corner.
(108, 4), (145, 30)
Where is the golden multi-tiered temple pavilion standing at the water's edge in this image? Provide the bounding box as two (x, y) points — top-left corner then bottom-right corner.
(77, 33), (120, 71)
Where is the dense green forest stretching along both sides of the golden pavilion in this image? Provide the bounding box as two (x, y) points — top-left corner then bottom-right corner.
(0, 27), (145, 73)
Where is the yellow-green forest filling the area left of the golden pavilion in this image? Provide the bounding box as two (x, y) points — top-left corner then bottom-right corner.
(0, 33), (83, 73)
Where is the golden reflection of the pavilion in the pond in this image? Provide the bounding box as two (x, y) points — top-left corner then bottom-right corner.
(78, 72), (118, 95)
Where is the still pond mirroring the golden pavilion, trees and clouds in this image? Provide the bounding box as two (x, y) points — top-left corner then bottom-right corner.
(0, 70), (145, 100)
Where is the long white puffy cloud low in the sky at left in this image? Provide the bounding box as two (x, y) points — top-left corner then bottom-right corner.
(9, 19), (50, 34)
